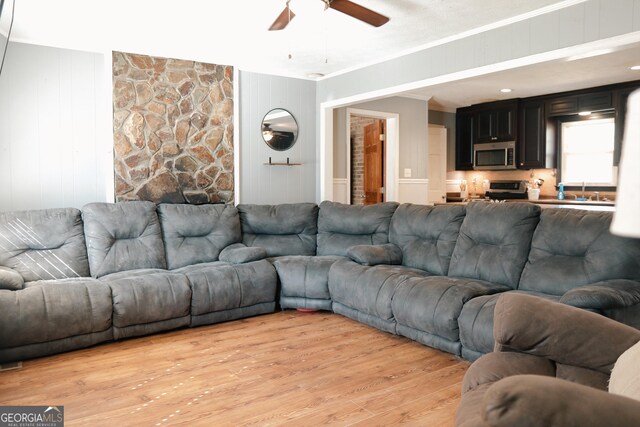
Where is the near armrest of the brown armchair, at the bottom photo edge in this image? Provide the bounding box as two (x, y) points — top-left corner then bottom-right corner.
(482, 375), (640, 427)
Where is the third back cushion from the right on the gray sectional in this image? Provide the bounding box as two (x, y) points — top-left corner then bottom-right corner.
(389, 203), (465, 276)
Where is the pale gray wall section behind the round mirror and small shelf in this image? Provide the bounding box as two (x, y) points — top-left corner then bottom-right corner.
(236, 71), (318, 204)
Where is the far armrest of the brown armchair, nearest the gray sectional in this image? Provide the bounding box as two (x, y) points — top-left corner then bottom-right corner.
(493, 292), (640, 375)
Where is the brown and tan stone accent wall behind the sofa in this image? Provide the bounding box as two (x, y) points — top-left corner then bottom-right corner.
(113, 52), (234, 204)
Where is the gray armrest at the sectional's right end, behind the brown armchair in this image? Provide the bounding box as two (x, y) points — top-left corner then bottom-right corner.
(560, 279), (640, 310)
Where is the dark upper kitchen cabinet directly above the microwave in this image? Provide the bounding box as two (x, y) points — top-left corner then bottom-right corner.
(476, 100), (518, 143)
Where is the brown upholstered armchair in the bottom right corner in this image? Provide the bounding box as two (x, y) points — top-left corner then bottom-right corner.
(455, 293), (640, 427)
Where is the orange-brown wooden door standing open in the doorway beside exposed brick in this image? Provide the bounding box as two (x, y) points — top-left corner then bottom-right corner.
(364, 120), (385, 205)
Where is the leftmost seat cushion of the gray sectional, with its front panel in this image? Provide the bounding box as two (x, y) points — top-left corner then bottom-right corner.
(0, 277), (112, 348)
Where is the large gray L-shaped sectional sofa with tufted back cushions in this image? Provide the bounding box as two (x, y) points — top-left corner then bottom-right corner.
(0, 202), (640, 363)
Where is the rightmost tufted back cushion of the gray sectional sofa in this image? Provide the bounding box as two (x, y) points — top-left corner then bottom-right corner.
(519, 209), (640, 295)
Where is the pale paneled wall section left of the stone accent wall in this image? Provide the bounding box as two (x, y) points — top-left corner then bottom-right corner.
(0, 42), (113, 211)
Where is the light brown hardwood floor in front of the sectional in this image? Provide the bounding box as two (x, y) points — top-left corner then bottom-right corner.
(0, 311), (469, 426)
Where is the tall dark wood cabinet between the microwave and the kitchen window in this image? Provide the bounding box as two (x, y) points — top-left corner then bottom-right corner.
(518, 100), (546, 169)
